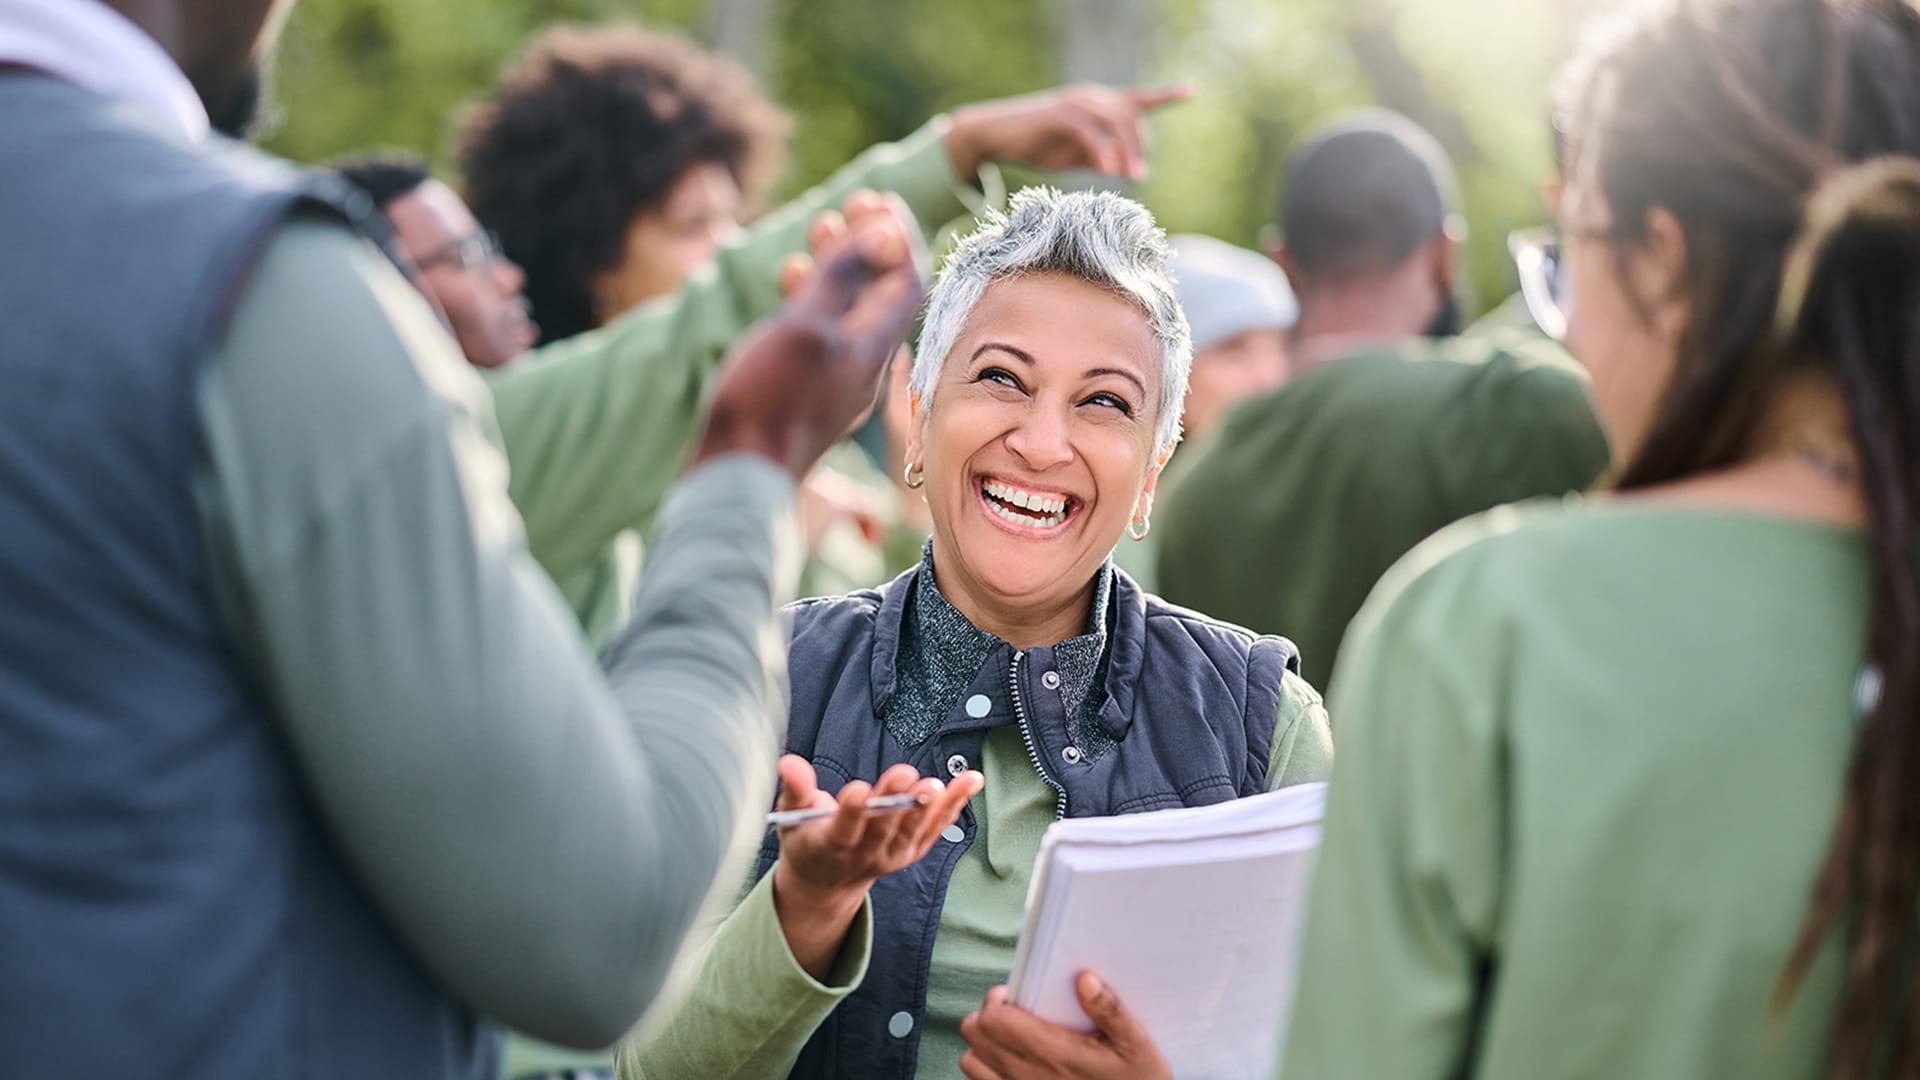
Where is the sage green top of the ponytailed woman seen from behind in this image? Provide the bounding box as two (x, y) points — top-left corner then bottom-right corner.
(1283, 498), (1868, 1080)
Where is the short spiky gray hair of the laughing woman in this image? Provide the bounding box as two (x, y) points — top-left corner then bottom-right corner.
(912, 188), (1194, 454)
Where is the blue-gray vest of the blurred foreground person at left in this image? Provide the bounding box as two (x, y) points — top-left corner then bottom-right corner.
(0, 69), (495, 1080)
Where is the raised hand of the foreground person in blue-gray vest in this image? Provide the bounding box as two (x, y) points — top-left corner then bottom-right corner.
(691, 192), (925, 477)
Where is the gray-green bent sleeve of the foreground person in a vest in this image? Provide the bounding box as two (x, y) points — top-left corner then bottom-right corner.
(206, 219), (797, 1045)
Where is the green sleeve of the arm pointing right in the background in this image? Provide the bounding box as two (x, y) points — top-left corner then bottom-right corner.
(488, 117), (998, 648)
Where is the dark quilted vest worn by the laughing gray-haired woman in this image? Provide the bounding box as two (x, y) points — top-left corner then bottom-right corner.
(758, 569), (1300, 1080)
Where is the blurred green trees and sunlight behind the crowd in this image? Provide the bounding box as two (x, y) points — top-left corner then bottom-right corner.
(265, 0), (1599, 307)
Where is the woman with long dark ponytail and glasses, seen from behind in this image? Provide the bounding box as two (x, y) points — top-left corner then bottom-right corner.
(1284, 0), (1920, 1080)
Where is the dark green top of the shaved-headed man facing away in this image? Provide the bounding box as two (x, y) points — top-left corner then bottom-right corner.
(1154, 336), (1607, 686)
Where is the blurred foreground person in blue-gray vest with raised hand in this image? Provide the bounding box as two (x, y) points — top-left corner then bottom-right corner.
(0, 0), (920, 1080)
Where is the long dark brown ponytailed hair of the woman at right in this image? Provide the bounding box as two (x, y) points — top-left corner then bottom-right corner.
(1561, 0), (1920, 1080)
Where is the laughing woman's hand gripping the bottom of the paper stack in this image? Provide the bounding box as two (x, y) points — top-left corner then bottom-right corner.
(960, 970), (1173, 1080)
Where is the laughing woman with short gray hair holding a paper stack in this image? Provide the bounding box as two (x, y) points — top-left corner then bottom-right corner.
(622, 188), (1332, 1080)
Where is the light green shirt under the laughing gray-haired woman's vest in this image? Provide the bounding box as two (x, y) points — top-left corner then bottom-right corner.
(620, 675), (1332, 1080)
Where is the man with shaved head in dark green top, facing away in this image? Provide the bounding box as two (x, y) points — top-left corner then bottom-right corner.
(1158, 110), (1607, 686)
